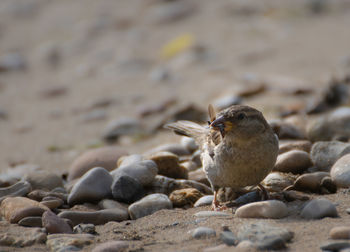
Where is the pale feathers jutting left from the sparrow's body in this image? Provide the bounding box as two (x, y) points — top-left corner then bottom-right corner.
(164, 121), (207, 141)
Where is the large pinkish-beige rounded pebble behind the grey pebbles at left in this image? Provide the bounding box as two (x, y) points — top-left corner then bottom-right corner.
(67, 147), (127, 181)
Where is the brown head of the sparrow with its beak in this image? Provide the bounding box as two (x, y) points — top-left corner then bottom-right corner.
(210, 105), (269, 138)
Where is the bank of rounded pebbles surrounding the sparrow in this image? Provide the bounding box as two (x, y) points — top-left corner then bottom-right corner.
(0, 81), (350, 252)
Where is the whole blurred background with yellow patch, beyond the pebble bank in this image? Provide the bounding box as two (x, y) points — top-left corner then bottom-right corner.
(0, 0), (350, 176)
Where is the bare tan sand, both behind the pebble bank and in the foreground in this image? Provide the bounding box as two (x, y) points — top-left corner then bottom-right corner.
(0, 0), (350, 251)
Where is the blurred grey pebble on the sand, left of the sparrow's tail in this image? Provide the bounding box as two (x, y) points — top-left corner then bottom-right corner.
(102, 118), (144, 142)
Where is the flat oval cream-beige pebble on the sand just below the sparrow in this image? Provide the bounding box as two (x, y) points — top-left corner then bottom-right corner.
(235, 200), (288, 219)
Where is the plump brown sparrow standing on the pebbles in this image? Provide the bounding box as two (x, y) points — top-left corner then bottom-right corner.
(165, 105), (278, 210)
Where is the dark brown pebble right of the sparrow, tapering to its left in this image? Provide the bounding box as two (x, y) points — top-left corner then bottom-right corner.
(290, 172), (337, 193)
